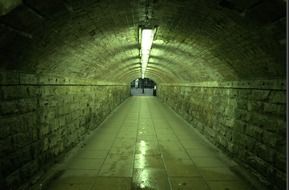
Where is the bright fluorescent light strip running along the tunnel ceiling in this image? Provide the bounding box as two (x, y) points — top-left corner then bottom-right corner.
(140, 28), (155, 78)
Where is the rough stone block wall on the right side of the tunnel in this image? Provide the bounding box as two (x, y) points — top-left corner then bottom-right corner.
(158, 81), (286, 189)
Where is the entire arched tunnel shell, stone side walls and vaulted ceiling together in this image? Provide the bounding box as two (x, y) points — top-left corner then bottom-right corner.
(0, 0), (287, 189)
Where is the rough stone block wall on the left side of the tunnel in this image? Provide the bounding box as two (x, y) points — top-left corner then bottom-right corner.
(0, 72), (129, 189)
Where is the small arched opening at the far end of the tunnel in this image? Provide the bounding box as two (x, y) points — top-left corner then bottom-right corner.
(130, 78), (157, 96)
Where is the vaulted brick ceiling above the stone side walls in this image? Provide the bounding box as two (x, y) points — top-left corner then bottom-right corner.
(0, 0), (286, 83)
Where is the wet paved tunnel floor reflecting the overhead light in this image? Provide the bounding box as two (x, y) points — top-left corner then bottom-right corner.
(48, 96), (250, 190)
